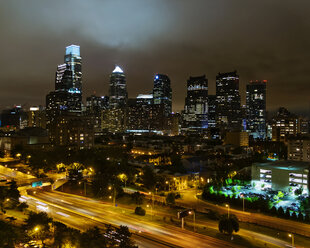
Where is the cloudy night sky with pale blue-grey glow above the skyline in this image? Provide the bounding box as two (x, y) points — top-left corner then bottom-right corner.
(0, 0), (310, 114)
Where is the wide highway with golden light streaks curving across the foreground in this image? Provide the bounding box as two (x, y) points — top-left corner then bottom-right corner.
(27, 192), (238, 248)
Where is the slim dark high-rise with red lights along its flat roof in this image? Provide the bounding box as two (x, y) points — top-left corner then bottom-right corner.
(246, 80), (267, 139)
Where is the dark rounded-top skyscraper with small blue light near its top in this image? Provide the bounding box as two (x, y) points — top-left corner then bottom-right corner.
(153, 74), (172, 117)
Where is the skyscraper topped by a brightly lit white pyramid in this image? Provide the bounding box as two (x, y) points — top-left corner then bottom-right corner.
(109, 66), (128, 109)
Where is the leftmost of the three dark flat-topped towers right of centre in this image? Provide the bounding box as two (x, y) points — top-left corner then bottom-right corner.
(183, 75), (208, 132)
